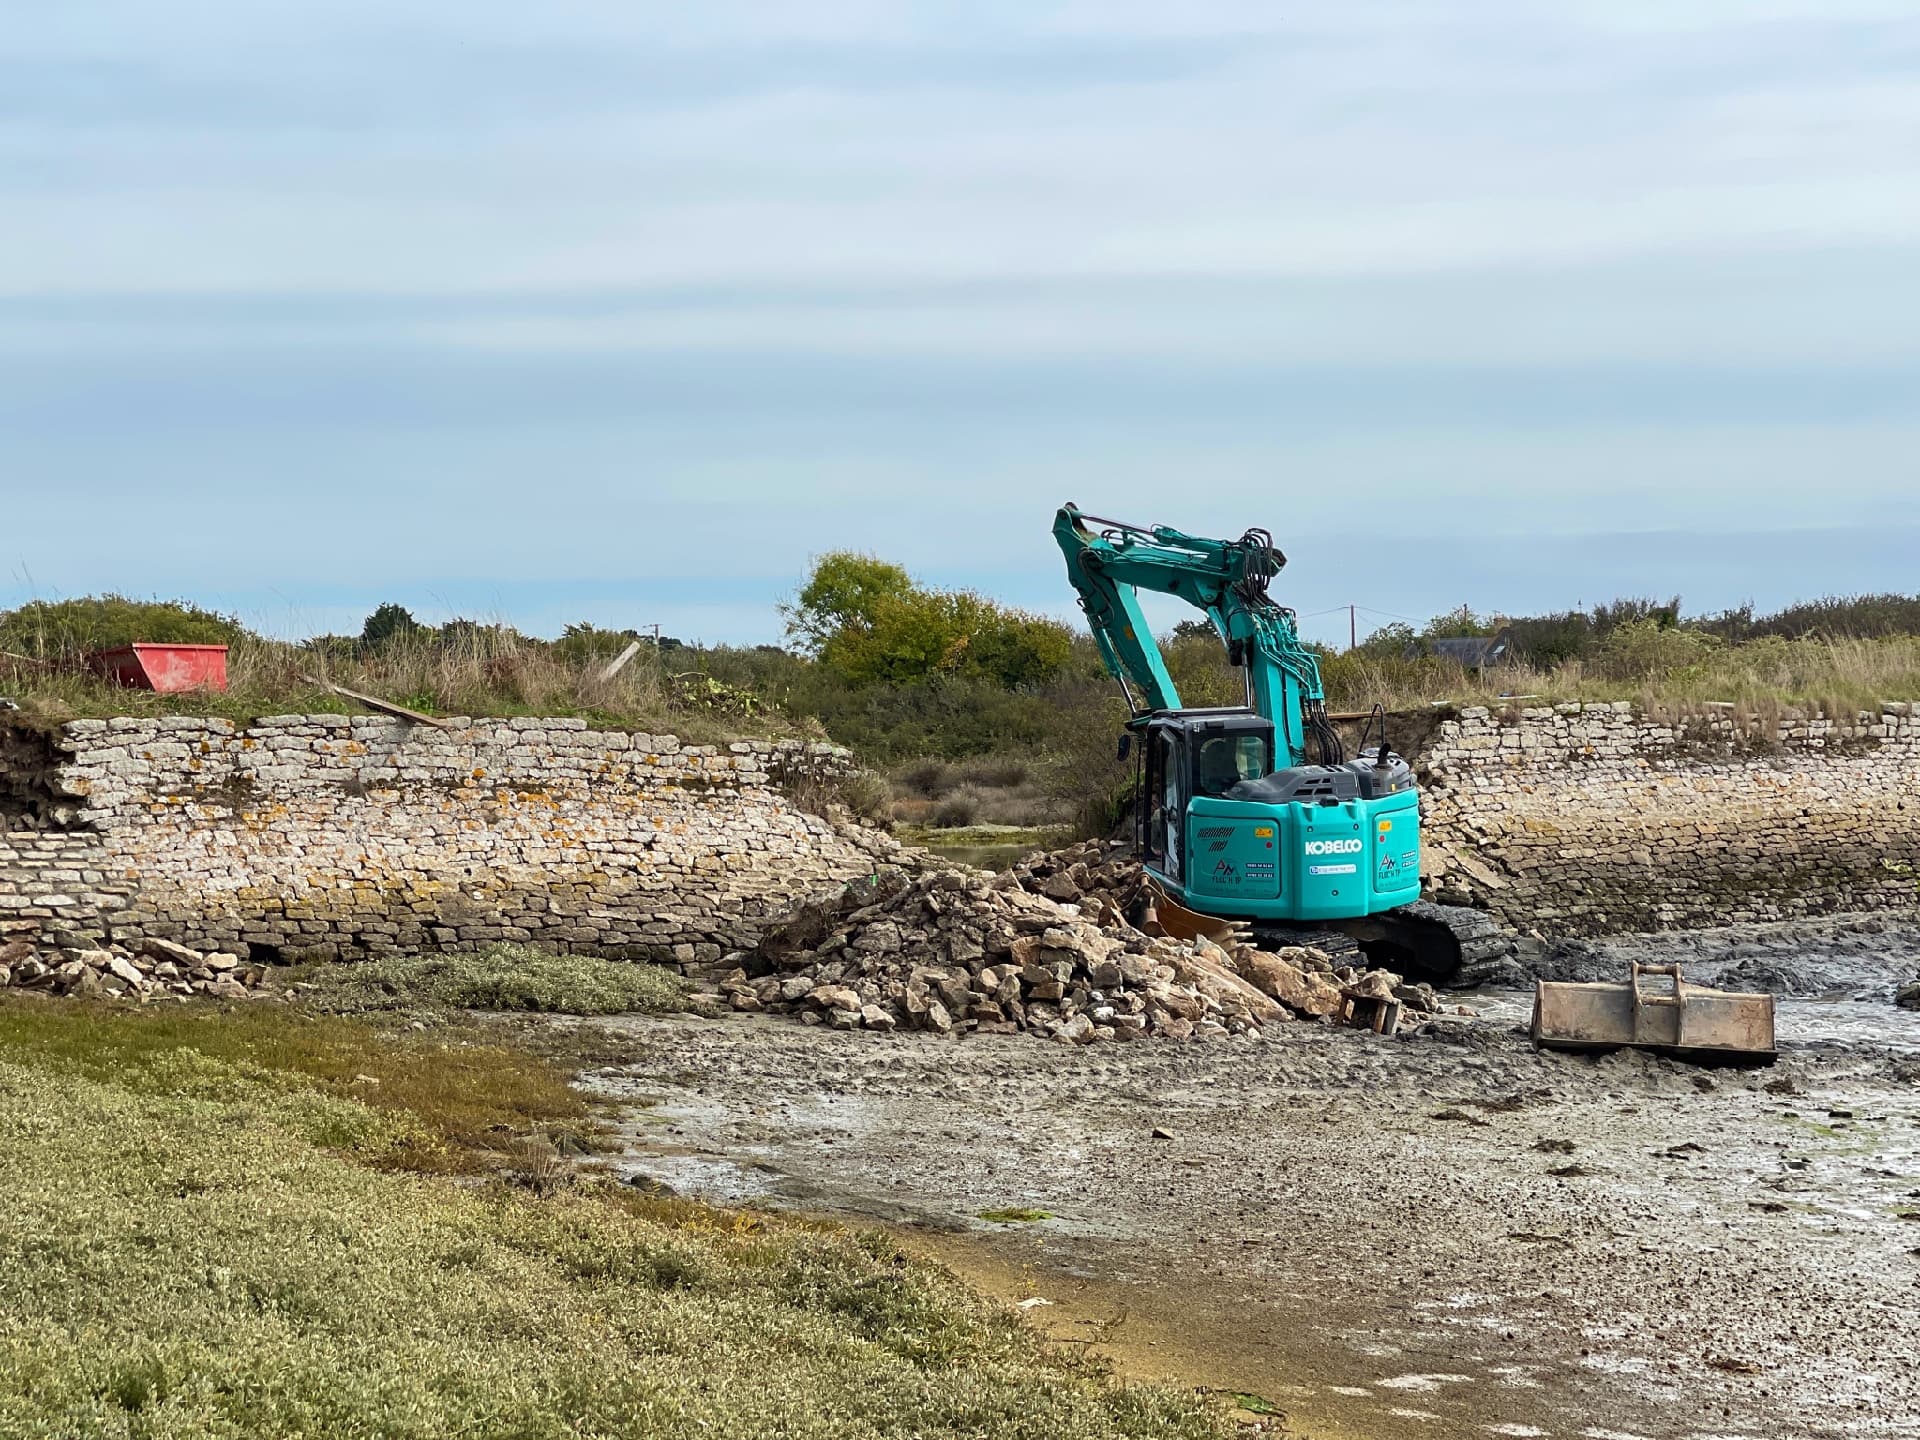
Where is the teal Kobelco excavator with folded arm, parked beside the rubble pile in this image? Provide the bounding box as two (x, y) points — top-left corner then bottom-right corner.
(1054, 505), (1511, 981)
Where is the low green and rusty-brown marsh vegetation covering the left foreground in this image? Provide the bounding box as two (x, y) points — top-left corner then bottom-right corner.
(0, 996), (1215, 1440)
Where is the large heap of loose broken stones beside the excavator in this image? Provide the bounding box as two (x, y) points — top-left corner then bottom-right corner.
(714, 845), (1440, 1043)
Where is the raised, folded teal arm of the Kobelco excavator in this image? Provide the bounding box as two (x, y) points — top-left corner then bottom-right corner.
(1054, 505), (1338, 764)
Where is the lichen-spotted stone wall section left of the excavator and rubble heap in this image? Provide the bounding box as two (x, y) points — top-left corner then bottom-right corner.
(0, 714), (897, 964)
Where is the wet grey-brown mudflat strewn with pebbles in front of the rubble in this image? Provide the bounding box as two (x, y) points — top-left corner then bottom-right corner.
(568, 933), (1920, 1440)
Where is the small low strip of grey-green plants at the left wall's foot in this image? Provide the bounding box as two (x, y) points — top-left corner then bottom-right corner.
(303, 945), (710, 1016)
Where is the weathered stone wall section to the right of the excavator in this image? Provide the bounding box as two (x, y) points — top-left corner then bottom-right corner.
(1417, 705), (1920, 937)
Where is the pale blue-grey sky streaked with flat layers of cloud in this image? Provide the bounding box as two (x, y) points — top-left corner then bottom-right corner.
(0, 0), (1920, 641)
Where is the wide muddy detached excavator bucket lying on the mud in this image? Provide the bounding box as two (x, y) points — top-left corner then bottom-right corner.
(1532, 964), (1776, 1064)
